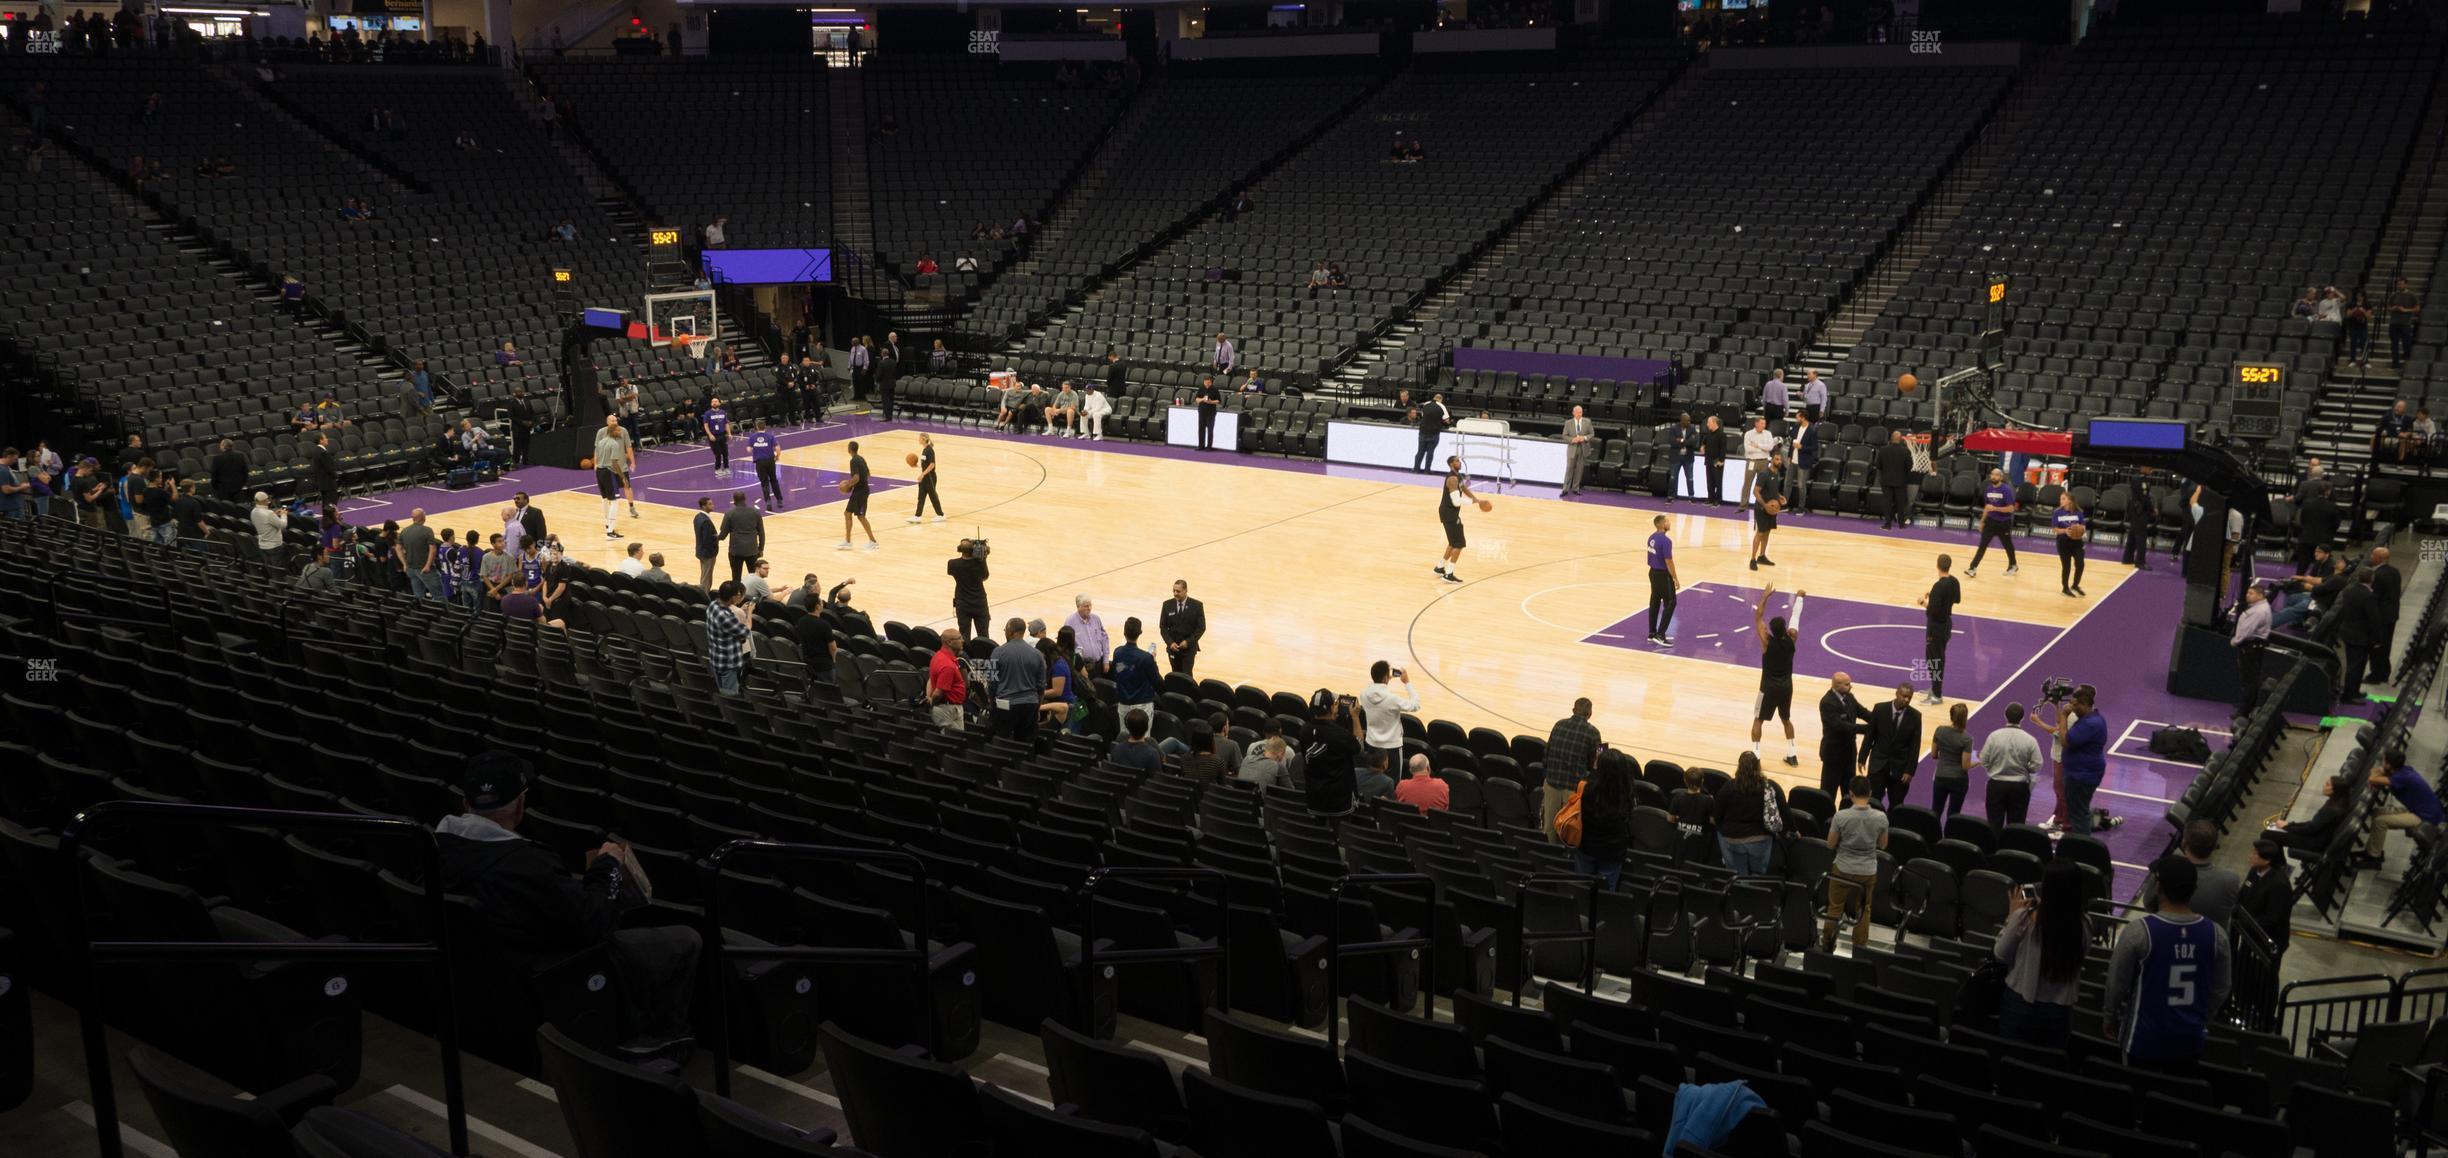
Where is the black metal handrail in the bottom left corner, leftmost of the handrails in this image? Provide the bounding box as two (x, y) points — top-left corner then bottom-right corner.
(59, 801), (468, 1158)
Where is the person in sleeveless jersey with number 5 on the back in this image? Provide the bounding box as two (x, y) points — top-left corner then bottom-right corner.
(2105, 857), (2233, 1075)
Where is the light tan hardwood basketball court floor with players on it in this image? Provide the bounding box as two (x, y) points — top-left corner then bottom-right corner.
(411, 428), (2159, 781)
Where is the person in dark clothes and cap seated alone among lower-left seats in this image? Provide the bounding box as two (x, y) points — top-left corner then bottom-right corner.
(433, 752), (703, 1065)
